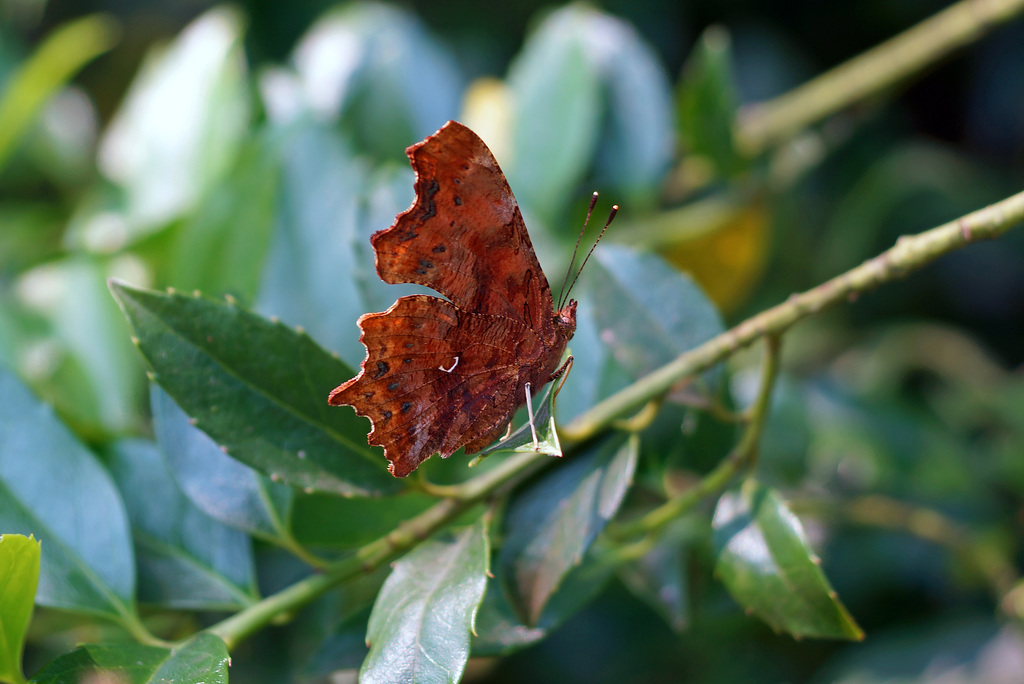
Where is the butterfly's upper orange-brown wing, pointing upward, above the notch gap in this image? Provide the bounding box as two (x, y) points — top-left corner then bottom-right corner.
(371, 122), (552, 330)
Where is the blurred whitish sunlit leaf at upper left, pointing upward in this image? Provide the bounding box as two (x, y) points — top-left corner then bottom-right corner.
(95, 7), (250, 236)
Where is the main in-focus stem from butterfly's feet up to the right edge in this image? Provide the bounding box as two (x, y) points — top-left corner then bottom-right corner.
(563, 187), (1024, 441)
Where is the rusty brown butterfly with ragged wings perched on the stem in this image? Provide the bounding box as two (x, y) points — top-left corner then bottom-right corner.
(328, 121), (581, 477)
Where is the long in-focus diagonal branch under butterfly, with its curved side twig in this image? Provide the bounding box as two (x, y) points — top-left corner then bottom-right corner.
(208, 187), (1024, 649)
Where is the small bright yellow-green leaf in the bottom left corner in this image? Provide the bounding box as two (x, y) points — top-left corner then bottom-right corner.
(0, 535), (39, 682)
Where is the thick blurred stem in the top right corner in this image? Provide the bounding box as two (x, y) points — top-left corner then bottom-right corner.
(735, 0), (1024, 156)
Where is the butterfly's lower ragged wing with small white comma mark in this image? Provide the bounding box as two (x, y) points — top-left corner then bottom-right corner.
(329, 295), (537, 476)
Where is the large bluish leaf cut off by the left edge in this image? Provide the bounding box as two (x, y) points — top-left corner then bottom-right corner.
(0, 369), (135, 622)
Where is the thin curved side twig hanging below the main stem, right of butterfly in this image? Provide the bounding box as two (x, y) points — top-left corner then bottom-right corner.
(608, 335), (779, 539)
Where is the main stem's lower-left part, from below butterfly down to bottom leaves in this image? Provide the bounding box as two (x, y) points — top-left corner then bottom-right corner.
(207, 444), (548, 650)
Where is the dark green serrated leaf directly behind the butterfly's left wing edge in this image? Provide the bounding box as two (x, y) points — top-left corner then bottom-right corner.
(111, 281), (401, 496)
